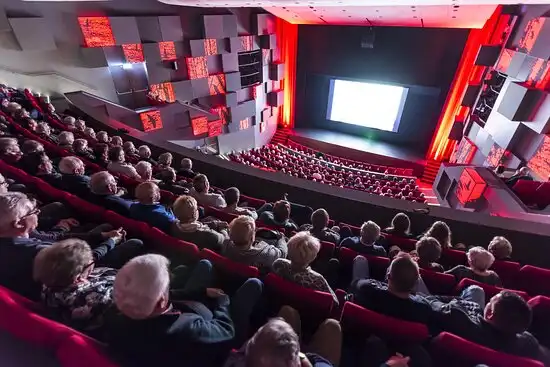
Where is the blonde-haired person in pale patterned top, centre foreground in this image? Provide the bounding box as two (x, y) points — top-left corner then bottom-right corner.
(273, 232), (338, 304)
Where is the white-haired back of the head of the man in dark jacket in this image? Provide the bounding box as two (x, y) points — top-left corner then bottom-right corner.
(113, 254), (170, 320)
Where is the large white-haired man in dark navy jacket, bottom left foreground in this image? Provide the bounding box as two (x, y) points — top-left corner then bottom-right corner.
(107, 254), (262, 366)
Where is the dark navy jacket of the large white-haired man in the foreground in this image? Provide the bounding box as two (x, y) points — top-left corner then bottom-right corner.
(107, 295), (235, 367)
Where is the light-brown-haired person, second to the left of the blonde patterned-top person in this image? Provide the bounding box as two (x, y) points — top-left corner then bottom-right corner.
(170, 195), (228, 252)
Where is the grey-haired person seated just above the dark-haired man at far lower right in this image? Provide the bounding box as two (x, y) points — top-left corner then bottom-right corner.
(445, 246), (502, 287)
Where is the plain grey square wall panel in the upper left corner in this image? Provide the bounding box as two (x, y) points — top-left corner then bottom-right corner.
(9, 18), (57, 51)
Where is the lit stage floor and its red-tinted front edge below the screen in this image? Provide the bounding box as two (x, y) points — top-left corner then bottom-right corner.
(287, 129), (426, 177)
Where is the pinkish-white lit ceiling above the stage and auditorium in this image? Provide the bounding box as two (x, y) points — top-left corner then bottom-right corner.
(158, 0), (548, 28)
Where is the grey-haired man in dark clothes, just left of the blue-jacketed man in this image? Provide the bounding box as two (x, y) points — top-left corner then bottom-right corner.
(88, 171), (134, 216)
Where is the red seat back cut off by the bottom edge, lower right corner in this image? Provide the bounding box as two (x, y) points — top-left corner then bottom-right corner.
(430, 332), (544, 367)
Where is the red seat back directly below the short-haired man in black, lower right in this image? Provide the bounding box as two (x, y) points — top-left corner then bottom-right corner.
(341, 302), (430, 343)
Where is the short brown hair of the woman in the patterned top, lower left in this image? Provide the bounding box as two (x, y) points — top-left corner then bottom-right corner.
(33, 238), (94, 288)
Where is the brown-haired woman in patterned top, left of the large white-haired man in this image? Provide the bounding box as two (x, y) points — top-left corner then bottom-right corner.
(33, 238), (116, 331)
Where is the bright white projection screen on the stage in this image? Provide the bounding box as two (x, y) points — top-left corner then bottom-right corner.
(327, 79), (409, 132)
